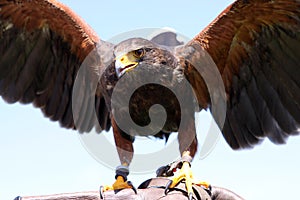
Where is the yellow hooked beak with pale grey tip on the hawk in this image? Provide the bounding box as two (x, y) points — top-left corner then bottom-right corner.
(115, 53), (139, 78)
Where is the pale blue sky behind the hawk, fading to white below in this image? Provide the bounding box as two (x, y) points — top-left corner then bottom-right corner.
(0, 0), (300, 200)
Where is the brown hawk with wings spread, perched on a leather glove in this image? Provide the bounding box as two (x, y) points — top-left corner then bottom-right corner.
(0, 0), (300, 198)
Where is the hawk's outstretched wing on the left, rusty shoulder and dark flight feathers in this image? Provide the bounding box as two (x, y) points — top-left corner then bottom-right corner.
(0, 0), (110, 132)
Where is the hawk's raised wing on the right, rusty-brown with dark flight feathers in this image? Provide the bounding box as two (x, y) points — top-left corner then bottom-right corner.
(191, 0), (300, 149)
